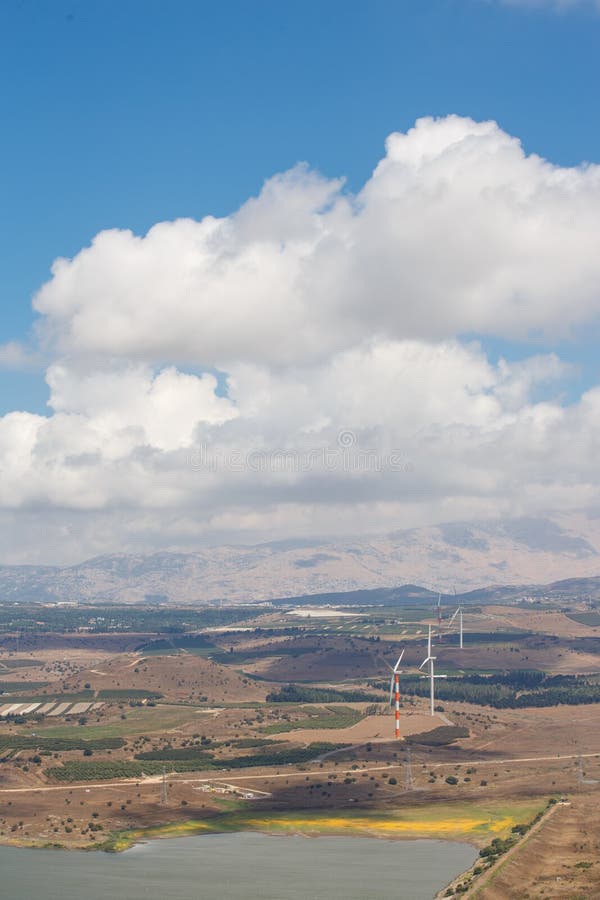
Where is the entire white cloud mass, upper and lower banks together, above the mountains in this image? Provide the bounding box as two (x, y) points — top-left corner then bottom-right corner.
(0, 116), (600, 561)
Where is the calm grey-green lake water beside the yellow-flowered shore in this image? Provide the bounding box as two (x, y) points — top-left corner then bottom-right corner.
(0, 832), (477, 900)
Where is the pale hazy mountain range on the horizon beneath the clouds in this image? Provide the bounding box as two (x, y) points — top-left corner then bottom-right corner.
(0, 516), (600, 603)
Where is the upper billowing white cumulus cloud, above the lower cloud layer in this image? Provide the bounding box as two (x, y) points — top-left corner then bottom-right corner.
(35, 116), (600, 367)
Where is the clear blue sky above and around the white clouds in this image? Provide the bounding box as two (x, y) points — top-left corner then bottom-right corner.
(0, 0), (600, 409)
